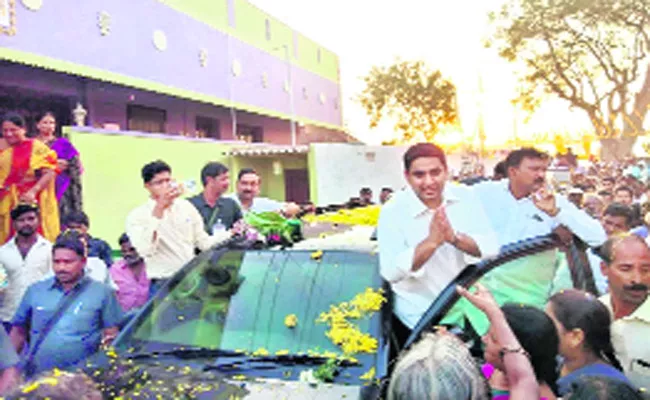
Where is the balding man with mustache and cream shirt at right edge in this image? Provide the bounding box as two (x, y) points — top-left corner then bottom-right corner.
(600, 235), (650, 388)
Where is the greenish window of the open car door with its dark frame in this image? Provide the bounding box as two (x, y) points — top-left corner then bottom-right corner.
(407, 235), (594, 346)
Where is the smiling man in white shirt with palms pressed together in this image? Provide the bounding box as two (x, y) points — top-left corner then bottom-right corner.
(378, 143), (498, 344)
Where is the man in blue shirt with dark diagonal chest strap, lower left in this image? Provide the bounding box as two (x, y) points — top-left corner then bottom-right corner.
(10, 231), (122, 373)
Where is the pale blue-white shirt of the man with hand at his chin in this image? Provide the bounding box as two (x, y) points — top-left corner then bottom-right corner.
(471, 179), (607, 247)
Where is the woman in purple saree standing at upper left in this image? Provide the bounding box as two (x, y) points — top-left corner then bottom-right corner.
(36, 111), (83, 221)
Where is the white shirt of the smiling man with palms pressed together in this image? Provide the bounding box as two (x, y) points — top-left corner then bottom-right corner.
(378, 184), (498, 329)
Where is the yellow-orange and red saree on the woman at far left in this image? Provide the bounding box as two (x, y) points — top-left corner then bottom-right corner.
(0, 139), (60, 243)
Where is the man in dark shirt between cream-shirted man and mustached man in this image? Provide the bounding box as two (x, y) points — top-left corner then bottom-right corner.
(188, 162), (242, 235)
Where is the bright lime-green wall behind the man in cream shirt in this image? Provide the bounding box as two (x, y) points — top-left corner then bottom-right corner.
(65, 129), (228, 247)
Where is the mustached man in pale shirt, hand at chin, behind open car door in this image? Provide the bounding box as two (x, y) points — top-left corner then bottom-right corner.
(443, 148), (607, 335)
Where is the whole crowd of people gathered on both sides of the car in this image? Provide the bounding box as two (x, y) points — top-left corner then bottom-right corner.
(0, 104), (650, 399)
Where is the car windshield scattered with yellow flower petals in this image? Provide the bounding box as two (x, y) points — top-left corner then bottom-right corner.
(116, 250), (381, 362)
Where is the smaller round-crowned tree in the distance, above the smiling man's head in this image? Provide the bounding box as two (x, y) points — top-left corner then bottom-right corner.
(358, 60), (458, 141)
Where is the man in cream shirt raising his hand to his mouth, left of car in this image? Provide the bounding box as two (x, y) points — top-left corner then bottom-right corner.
(126, 161), (232, 285)
